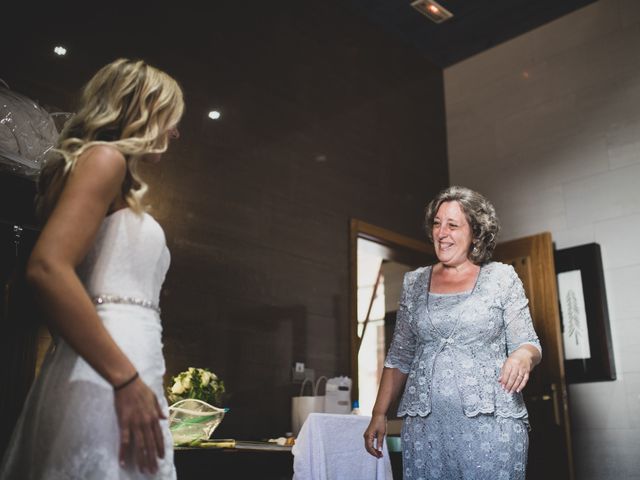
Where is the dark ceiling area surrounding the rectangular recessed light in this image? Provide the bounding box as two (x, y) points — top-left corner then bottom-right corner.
(351, 0), (596, 68)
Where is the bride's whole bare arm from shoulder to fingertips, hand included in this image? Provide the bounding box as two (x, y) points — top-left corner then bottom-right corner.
(27, 146), (164, 471)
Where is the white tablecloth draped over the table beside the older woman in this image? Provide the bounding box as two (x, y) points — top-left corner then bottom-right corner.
(292, 413), (393, 480)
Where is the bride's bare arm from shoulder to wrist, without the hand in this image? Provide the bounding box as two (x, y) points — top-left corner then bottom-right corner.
(27, 147), (135, 385)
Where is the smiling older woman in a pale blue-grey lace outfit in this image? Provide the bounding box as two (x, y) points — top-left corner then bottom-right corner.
(364, 187), (541, 480)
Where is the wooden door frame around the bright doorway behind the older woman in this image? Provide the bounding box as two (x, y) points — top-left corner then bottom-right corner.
(349, 218), (435, 398)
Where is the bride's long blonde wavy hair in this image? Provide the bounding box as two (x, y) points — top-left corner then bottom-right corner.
(36, 58), (184, 221)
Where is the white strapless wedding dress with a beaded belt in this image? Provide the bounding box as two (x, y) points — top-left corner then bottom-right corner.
(0, 208), (176, 480)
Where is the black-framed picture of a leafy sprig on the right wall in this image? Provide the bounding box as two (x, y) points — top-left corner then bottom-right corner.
(555, 243), (616, 383)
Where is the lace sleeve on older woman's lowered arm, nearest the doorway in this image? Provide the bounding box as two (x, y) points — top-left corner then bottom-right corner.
(384, 272), (416, 374)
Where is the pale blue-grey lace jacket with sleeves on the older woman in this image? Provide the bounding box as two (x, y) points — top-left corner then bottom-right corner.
(385, 262), (540, 418)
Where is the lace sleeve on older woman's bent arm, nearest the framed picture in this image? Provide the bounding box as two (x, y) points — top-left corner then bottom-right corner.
(504, 266), (542, 355)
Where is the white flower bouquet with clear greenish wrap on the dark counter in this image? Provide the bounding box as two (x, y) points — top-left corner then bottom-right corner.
(167, 367), (228, 445)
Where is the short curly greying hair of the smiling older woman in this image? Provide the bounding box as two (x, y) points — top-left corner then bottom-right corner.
(424, 186), (500, 265)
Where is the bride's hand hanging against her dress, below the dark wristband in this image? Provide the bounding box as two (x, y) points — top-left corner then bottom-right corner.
(114, 378), (166, 473)
